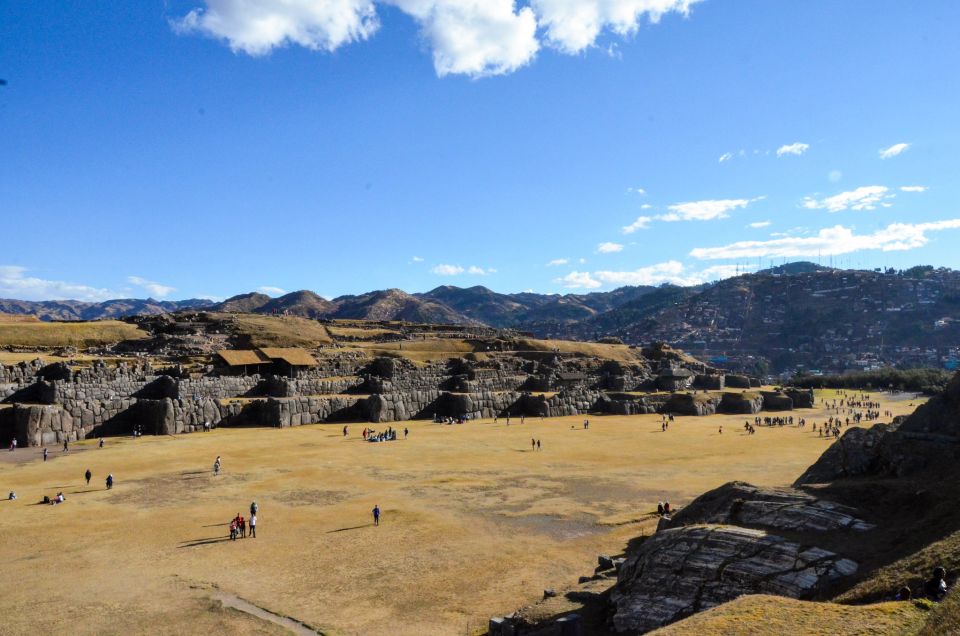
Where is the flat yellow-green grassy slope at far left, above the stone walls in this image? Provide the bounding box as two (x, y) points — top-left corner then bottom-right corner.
(0, 320), (147, 348)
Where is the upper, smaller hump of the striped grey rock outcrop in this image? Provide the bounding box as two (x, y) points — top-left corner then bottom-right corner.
(658, 481), (874, 532)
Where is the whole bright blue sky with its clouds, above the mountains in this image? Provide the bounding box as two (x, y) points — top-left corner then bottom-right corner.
(0, 0), (960, 300)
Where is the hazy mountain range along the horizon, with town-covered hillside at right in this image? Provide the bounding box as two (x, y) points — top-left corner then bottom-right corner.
(0, 262), (960, 372)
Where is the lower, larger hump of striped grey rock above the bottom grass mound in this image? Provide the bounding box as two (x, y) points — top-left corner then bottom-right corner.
(611, 525), (857, 632)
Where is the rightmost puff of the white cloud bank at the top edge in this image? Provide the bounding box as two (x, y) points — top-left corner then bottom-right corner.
(530, 0), (697, 53)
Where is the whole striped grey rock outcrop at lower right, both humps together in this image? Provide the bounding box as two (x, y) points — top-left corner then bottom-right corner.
(611, 482), (873, 632)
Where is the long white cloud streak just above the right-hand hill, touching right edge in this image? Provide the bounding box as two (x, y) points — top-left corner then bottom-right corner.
(690, 219), (960, 260)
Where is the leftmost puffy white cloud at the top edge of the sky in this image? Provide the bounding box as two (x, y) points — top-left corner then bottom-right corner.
(174, 0), (379, 55)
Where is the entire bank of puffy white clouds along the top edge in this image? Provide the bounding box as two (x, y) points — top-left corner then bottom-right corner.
(172, 0), (699, 77)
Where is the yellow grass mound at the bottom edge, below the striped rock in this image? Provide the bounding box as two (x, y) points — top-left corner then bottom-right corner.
(652, 595), (927, 636)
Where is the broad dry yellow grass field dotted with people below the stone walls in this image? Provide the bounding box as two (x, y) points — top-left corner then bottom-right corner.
(0, 390), (912, 634)
